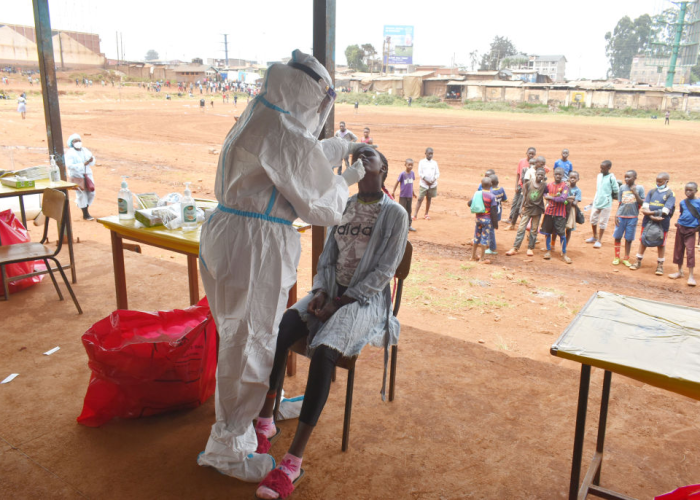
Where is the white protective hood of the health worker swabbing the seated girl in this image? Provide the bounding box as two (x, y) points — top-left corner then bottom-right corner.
(264, 50), (335, 137)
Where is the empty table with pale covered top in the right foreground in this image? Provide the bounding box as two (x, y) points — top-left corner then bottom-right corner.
(551, 292), (700, 500)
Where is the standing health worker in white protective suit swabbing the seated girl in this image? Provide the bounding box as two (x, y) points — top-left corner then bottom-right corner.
(197, 50), (364, 482)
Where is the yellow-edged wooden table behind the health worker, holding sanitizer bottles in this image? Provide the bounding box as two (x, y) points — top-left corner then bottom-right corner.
(97, 210), (311, 375)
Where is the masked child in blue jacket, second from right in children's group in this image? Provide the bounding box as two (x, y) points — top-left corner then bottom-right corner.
(629, 172), (676, 276)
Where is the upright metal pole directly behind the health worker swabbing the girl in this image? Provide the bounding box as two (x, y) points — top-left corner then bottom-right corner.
(311, 0), (335, 276)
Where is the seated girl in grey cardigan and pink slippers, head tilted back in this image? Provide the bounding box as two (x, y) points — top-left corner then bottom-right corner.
(255, 146), (408, 498)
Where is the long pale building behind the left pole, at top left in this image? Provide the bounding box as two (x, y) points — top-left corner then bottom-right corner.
(0, 23), (105, 69)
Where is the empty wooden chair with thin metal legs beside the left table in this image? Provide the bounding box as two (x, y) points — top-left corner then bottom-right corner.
(0, 189), (83, 314)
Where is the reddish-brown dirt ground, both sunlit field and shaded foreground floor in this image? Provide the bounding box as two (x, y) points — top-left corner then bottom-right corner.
(0, 76), (700, 499)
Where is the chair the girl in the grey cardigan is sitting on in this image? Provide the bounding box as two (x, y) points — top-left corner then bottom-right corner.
(275, 241), (413, 451)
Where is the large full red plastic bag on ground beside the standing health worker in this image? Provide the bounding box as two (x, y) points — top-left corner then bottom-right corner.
(78, 297), (217, 427)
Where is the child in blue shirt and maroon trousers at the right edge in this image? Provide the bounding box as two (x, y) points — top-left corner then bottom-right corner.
(668, 182), (700, 286)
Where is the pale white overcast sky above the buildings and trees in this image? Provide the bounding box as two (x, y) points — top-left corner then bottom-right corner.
(5, 0), (671, 79)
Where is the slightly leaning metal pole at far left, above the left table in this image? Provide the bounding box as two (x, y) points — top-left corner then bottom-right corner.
(33, 0), (66, 181)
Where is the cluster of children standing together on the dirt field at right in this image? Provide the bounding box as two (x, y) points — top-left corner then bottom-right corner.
(456, 148), (700, 286)
